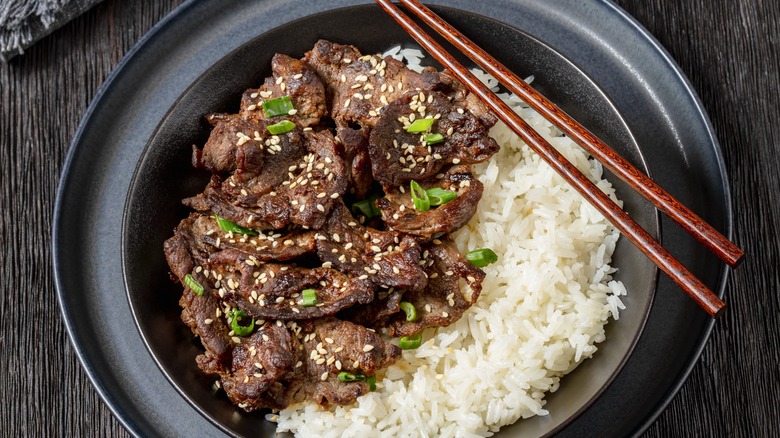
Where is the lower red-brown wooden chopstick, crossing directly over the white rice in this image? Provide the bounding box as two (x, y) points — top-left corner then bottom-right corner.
(375, 0), (726, 318)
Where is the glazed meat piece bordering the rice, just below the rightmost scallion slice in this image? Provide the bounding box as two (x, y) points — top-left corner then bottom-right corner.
(388, 240), (485, 337)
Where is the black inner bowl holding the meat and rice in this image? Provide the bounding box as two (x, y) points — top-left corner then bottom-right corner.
(122, 5), (658, 436)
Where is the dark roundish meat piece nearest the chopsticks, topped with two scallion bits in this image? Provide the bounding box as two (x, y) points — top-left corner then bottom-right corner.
(368, 92), (498, 188)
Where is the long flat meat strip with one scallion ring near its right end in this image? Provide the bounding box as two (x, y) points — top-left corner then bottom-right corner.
(204, 250), (374, 320)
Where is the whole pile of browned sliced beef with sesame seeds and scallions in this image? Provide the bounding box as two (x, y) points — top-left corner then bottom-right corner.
(164, 41), (498, 411)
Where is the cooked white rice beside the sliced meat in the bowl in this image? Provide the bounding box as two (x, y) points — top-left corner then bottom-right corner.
(270, 49), (626, 438)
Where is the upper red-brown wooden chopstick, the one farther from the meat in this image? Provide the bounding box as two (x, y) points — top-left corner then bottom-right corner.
(399, 0), (745, 266)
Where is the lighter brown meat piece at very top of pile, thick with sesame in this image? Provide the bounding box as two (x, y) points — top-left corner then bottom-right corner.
(304, 40), (444, 128)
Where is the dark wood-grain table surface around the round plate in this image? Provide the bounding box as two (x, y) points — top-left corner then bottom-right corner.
(0, 0), (780, 437)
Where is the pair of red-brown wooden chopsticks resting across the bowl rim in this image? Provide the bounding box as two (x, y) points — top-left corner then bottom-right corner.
(376, 0), (744, 318)
